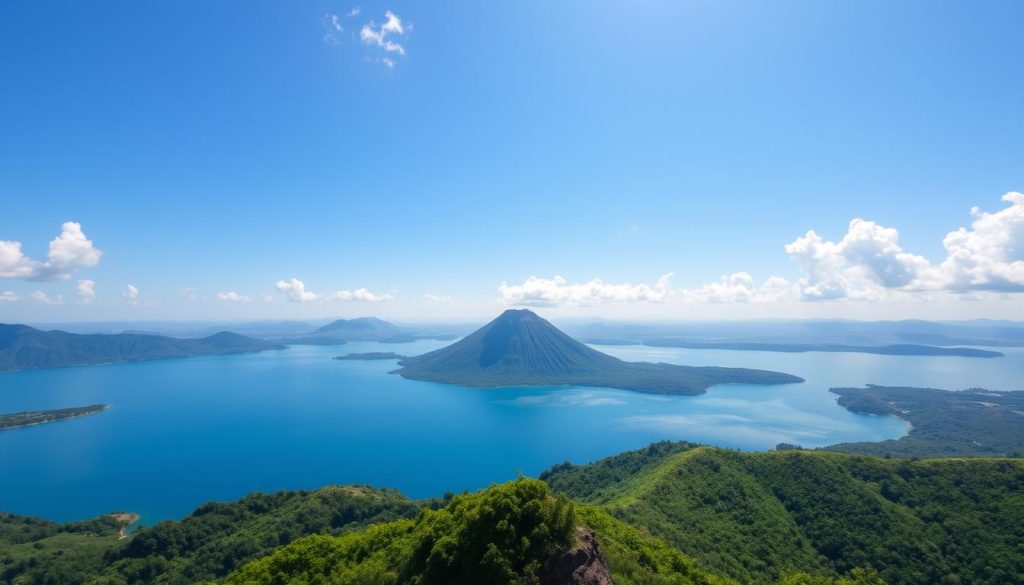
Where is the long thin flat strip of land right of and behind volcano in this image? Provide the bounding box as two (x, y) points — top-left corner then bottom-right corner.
(643, 339), (1004, 358)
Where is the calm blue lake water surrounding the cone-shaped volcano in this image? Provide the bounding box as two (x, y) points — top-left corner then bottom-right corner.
(0, 341), (1024, 523)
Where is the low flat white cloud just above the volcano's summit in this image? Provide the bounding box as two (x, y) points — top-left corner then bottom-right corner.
(498, 273), (672, 306)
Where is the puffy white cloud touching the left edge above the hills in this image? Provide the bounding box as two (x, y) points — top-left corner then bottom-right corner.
(0, 221), (103, 281)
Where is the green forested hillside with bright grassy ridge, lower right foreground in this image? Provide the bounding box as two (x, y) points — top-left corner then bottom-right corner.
(542, 444), (1024, 585)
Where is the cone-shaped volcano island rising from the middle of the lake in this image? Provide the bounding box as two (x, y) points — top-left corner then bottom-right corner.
(395, 309), (803, 394)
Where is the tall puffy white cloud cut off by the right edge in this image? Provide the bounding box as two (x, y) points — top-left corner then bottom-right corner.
(940, 193), (1024, 292)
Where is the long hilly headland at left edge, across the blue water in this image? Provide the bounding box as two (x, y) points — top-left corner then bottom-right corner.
(0, 324), (284, 371)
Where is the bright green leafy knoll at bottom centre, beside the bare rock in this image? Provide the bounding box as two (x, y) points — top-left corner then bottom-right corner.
(228, 478), (575, 585)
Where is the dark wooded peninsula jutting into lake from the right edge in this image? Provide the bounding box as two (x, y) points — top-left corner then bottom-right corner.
(826, 385), (1024, 457)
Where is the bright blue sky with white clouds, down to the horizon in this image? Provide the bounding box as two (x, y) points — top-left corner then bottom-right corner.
(0, 1), (1024, 322)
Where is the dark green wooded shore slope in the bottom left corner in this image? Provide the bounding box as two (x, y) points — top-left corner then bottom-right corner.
(0, 486), (419, 585)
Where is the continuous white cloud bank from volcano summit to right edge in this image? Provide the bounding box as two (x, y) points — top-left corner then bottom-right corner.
(498, 192), (1024, 307)
